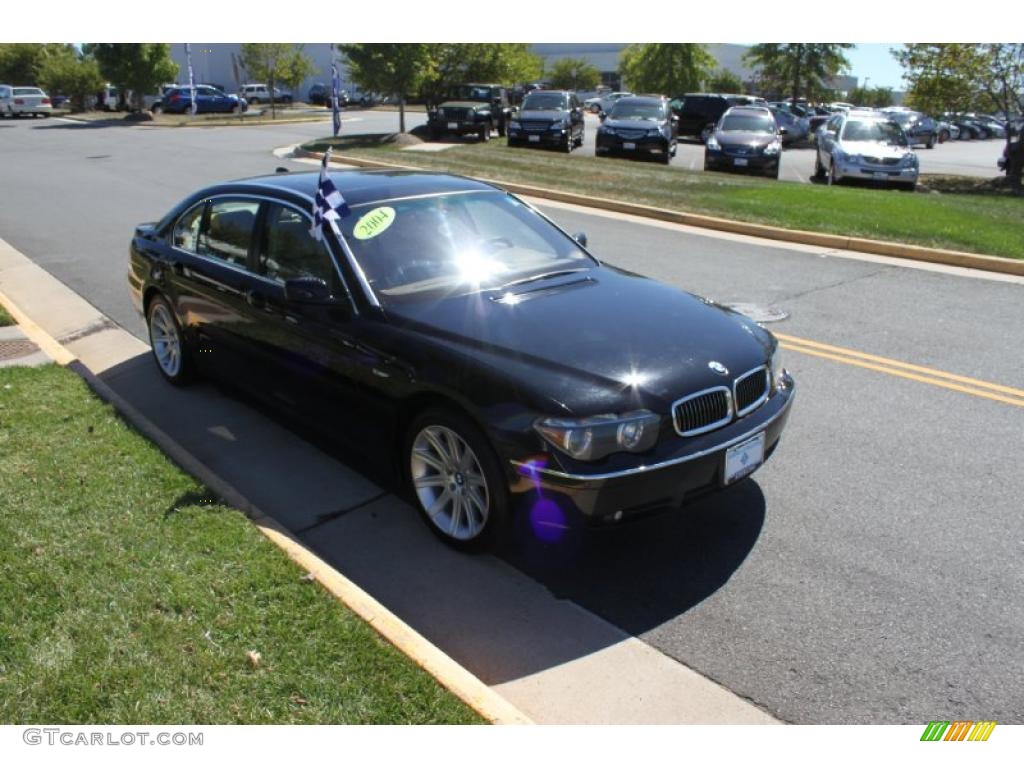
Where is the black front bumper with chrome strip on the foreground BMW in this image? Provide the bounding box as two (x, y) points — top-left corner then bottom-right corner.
(510, 375), (796, 523)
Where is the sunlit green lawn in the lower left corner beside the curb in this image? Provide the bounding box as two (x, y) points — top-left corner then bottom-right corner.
(0, 366), (480, 724)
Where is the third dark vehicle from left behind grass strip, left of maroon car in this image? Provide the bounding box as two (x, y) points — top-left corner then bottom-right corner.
(594, 96), (677, 165)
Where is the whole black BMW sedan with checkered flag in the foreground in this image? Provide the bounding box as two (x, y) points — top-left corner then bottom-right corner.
(129, 171), (794, 547)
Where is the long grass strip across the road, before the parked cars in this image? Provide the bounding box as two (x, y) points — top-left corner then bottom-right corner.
(305, 136), (1024, 258)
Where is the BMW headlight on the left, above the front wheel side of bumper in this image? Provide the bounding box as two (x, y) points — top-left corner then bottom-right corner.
(534, 411), (662, 461)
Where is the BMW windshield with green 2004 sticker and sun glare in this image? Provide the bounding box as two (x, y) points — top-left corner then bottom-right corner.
(341, 191), (596, 305)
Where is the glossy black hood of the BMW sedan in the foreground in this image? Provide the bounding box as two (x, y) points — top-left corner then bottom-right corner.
(387, 266), (772, 415)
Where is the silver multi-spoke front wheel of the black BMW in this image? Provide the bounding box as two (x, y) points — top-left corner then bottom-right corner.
(410, 424), (490, 542)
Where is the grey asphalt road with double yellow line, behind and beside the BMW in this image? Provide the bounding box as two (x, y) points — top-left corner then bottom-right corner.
(0, 113), (1024, 723)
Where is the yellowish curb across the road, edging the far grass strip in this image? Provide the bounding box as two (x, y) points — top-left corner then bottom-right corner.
(295, 146), (1024, 276)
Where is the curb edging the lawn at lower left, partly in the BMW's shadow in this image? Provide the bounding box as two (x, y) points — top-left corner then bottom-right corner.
(0, 284), (532, 725)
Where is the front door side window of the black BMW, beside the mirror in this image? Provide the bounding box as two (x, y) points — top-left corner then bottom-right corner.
(259, 205), (335, 287)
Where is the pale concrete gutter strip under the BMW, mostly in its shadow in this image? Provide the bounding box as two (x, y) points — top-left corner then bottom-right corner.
(0, 241), (778, 724)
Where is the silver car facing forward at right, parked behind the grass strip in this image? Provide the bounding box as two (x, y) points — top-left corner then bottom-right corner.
(814, 111), (921, 190)
